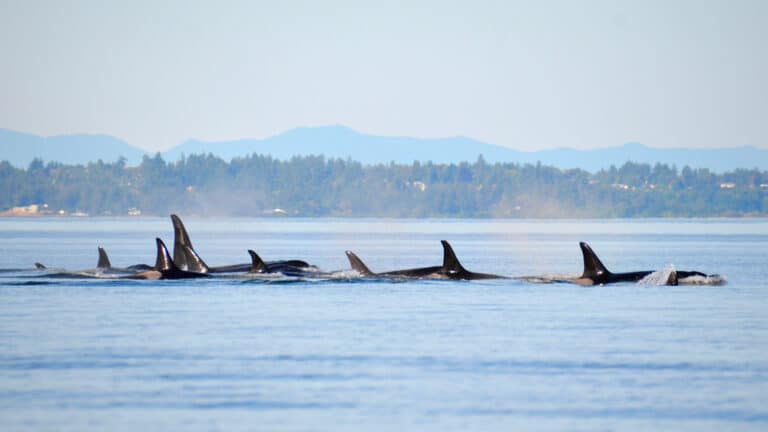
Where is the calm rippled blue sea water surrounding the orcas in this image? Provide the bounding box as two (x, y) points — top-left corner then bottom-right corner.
(0, 218), (768, 431)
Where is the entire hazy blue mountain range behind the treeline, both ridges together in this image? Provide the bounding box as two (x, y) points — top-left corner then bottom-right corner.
(0, 126), (768, 172)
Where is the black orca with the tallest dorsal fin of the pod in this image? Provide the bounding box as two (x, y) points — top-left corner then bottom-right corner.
(171, 214), (312, 273)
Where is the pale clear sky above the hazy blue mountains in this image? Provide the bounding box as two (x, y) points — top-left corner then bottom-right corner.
(0, 0), (768, 151)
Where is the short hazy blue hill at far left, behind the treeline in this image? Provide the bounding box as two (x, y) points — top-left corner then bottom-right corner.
(0, 129), (144, 168)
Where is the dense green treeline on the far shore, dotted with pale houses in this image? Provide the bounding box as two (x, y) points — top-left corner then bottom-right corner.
(0, 154), (768, 218)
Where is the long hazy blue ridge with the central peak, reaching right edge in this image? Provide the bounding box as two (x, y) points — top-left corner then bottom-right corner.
(164, 126), (768, 172)
